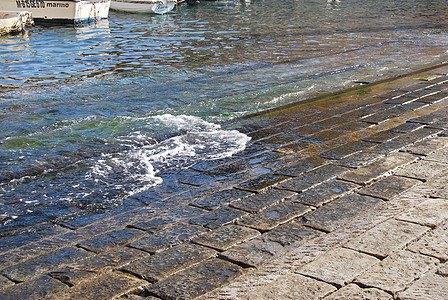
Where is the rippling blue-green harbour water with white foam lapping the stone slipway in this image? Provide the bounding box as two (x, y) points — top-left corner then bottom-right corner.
(0, 0), (448, 236)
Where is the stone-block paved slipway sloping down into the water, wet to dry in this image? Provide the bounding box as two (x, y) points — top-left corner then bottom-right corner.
(0, 65), (448, 300)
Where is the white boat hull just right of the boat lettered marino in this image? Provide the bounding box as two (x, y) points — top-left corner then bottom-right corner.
(110, 0), (177, 14)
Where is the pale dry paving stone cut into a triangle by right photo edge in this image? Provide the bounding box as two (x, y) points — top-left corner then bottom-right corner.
(408, 223), (448, 261)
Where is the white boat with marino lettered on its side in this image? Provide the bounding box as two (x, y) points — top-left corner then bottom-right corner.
(0, 0), (110, 23)
